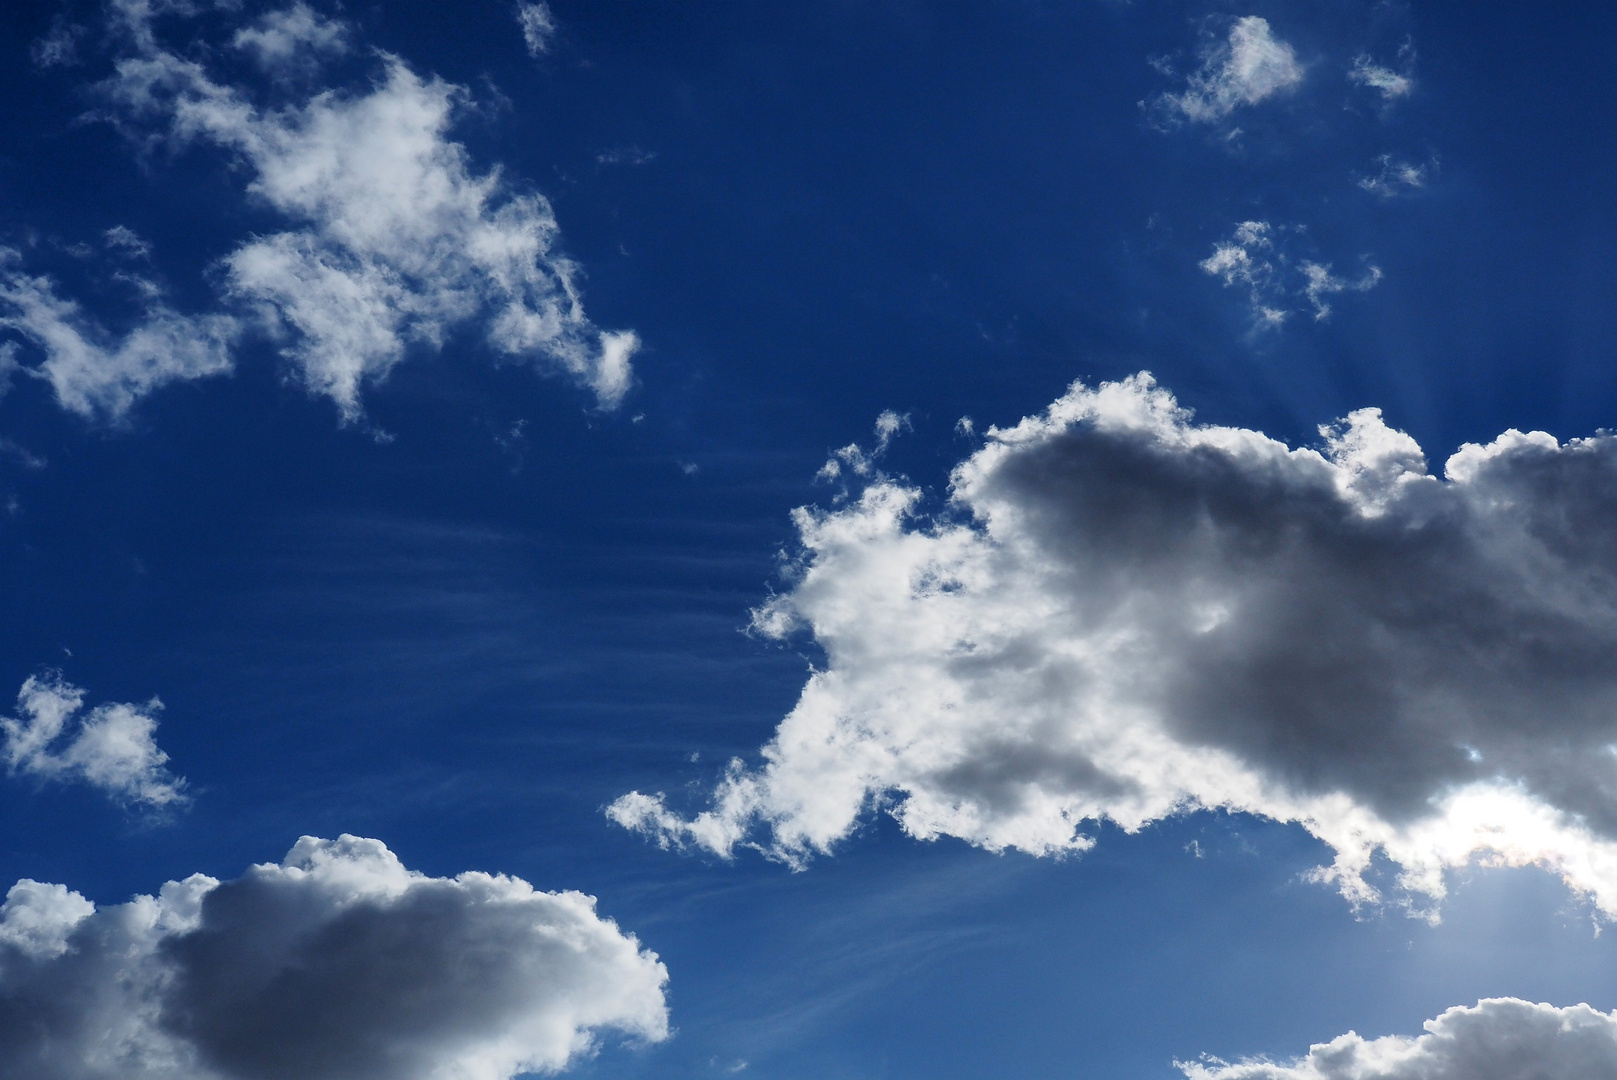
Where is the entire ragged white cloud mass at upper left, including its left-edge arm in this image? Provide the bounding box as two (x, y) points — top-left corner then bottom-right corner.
(0, 3), (639, 419)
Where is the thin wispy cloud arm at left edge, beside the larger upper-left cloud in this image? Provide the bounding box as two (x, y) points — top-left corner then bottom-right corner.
(0, 250), (241, 420)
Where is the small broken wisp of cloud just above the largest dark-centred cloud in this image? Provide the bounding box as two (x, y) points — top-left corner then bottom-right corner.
(1197, 221), (1381, 327)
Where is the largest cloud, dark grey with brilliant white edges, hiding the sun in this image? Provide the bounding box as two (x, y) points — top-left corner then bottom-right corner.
(610, 375), (1617, 915)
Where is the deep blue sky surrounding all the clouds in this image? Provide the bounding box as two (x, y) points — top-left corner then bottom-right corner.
(0, 0), (1617, 1080)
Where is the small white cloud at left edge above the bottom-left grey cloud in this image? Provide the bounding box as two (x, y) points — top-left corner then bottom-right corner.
(0, 673), (188, 807)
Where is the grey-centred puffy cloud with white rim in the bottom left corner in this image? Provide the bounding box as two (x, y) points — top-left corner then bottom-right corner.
(0, 836), (668, 1080)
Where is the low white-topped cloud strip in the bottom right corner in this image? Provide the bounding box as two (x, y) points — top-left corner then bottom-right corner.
(1179, 998), (1617, 1080)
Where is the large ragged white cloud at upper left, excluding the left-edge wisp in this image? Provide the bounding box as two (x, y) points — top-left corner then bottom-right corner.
(96, 8), (639, 417)
